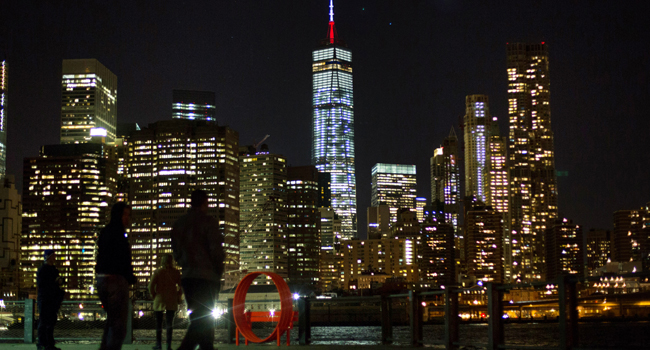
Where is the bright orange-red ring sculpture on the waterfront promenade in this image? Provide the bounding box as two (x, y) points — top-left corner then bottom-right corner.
(233, 272), (293, 345)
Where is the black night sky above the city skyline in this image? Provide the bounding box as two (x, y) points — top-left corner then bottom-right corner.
(0, 0), (650, 237)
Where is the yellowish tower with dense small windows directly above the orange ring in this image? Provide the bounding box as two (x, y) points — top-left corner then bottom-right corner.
(239, 145), (289, 284)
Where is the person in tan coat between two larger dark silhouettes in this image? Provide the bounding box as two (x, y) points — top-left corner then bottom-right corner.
(149, 254), (183, 350)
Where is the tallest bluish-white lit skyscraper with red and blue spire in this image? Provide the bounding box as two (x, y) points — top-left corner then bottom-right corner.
(311, 0), (357, 239)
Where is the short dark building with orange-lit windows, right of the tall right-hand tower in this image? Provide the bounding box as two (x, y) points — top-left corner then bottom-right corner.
(546, 219), (584, 281)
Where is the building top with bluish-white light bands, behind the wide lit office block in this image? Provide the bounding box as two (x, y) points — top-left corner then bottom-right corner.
(172, 90), (217, 121)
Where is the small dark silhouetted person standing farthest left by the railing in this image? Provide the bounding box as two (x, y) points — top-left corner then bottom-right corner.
(36, 249), (65, 350)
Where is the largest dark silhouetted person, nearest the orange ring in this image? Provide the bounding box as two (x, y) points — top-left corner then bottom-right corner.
(171, 190), (224, 350)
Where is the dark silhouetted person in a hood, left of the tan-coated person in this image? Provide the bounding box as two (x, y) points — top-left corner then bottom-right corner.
(95, 202), (136, 350)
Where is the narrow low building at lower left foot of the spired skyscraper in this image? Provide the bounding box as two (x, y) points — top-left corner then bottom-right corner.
(318, 206), (343, 291)
